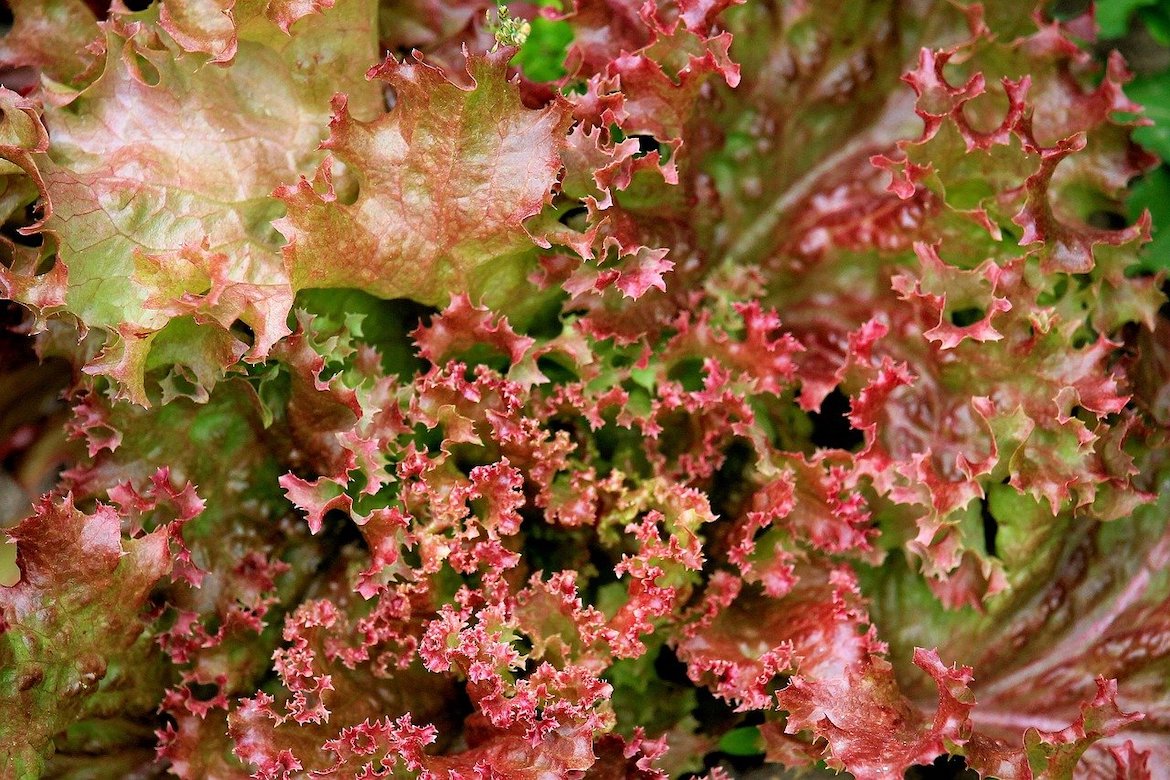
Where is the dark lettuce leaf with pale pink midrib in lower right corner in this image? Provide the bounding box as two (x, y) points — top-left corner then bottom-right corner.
(867, 463), (1170, 776)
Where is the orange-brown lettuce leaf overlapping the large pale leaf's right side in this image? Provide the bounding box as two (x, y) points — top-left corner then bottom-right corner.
(278, 49), (571, 304)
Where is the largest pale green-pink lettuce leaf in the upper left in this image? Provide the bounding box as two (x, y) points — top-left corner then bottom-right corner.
(0, 0), (379, 403)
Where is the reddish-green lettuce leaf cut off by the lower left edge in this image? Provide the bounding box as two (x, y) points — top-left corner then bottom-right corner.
(0, 496), (171, 778)
